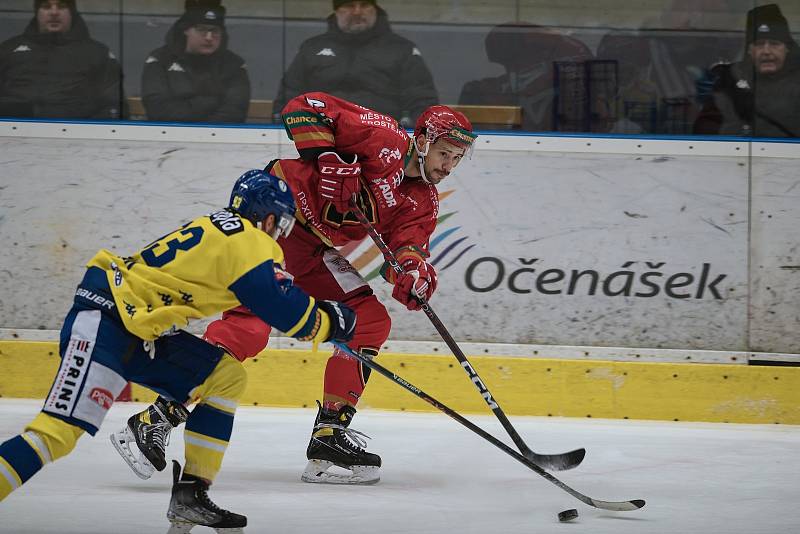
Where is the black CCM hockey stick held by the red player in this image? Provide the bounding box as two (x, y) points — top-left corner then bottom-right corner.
(350, 200), (586, 471)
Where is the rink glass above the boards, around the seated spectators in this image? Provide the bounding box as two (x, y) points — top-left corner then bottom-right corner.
(0, 0), (800, 135)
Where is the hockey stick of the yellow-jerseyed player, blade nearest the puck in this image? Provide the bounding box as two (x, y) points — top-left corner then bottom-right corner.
(333, 342), (645, 512)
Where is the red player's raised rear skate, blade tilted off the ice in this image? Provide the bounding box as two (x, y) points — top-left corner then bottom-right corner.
(111, 397), (189, 480)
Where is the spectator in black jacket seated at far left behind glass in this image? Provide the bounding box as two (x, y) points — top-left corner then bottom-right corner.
(0, 0), (124, 119)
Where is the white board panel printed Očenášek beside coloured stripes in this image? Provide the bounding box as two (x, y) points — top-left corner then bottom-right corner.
(366, 152), (748, 350)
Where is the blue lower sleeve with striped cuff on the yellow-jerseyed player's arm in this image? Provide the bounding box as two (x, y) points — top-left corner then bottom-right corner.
(228, 260), (320, 339)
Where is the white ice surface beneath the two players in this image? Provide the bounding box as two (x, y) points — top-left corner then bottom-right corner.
(0, 399), (800, 534)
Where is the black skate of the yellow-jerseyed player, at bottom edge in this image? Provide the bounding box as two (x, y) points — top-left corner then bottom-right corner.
(167, 460), (247, 534)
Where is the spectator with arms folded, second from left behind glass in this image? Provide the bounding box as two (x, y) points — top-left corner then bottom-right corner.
(142, 0), (250, 122)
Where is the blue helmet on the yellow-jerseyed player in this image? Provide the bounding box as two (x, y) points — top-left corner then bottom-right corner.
(228, 169), (295, 239)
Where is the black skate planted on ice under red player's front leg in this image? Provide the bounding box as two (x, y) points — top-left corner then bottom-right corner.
(301, 402), (381, 484)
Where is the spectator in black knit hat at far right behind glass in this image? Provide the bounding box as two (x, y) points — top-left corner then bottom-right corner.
(695, 4), (800, 137)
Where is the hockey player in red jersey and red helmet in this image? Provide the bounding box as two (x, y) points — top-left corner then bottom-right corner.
(116, 93), (476, 490)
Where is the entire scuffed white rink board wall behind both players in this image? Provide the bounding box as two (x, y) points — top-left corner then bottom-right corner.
(0, 132), (800, 352)
